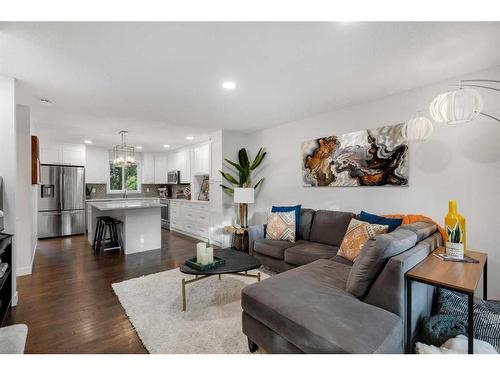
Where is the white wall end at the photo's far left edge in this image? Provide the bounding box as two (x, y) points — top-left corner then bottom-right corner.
(0, 76), (17, 305)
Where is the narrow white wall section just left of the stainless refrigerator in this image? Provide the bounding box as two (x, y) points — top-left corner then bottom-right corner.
(16, 105), (37, 276)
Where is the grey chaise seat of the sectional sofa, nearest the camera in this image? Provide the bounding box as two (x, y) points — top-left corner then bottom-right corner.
(241, 259), (402, 353)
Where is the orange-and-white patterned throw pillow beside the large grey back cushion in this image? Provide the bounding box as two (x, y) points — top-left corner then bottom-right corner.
(338, 219), (388, 262)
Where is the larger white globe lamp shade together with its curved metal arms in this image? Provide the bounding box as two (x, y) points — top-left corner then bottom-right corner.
(429, 79), (500, 125)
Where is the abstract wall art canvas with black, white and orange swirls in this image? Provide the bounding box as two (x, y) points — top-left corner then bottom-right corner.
(302, 124), (409, 186)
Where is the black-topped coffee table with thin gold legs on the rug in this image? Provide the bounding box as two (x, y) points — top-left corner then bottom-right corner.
(180, 248), (261, 311)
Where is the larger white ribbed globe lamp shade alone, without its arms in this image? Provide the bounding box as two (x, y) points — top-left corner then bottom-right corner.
(429, 87), (483, 125)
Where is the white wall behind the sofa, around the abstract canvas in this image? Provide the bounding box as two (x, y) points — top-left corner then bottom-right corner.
(249, 67), (500, 299)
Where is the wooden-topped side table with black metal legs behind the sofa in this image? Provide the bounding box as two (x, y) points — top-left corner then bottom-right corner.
(405, 247), (488, 354)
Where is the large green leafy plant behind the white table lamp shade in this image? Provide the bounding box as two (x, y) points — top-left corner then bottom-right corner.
(219, 147), (267, 194)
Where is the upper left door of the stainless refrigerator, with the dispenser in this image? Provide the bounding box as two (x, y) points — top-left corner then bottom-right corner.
(38, 165), (62, 211)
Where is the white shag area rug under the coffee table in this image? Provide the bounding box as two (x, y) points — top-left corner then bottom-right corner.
(112, 268), (269, 354)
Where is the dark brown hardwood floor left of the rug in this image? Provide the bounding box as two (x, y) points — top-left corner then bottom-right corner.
(7, 229), (197, 353)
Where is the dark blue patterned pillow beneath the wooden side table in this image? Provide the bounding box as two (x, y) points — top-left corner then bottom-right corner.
(437, 289), (500, 352)
